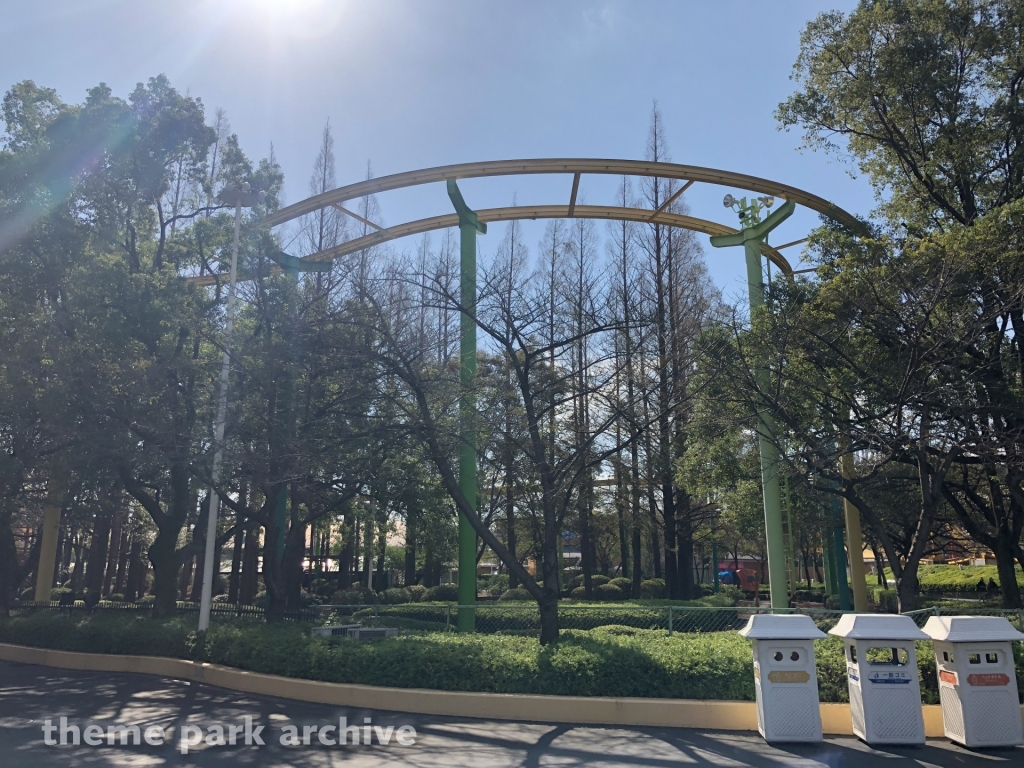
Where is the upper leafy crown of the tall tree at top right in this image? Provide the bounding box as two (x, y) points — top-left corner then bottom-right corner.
(776, 0), (1024, 229)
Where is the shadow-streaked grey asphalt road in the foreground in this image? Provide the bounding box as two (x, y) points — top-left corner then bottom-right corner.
(0, 662), (1024, 768)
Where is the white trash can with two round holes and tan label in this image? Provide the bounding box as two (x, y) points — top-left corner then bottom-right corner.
(739, 613), (825, 741)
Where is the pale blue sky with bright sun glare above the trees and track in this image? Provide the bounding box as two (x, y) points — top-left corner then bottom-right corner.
(0, 0), (874, 298)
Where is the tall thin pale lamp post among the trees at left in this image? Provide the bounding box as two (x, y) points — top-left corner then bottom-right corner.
(199, 182), (263, 632)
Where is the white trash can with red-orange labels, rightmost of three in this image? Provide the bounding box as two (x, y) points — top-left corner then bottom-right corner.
(925, 616), (1024, 748)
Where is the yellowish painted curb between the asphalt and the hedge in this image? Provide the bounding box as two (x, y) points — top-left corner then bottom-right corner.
(0, 643), (1024, 737)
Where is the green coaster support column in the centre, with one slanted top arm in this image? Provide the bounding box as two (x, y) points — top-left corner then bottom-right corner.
(447, 179), (487, 632)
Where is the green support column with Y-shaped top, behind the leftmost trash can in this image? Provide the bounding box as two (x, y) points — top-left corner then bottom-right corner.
(711, 201), (796, 608)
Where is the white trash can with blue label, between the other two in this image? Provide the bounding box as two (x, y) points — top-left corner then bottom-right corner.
(828, 613), (928, 744)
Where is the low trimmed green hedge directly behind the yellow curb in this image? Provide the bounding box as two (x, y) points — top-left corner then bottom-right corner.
(6, 606), (1024, 703)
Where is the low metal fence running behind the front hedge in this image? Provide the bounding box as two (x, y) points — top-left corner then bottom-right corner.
(18, 601), (1024, 636)
